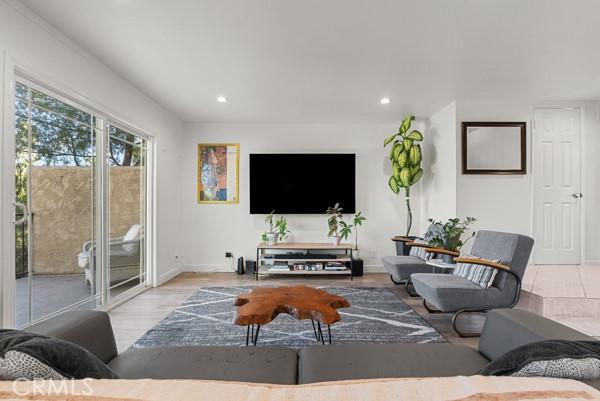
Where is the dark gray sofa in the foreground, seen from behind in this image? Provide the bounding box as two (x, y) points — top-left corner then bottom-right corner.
(27, 309), (600, 389)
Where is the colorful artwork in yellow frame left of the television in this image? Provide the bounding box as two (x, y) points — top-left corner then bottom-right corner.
(198, 143), (240, 203)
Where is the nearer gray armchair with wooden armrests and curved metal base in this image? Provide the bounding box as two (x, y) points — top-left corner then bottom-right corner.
(411, 230), (533, 337)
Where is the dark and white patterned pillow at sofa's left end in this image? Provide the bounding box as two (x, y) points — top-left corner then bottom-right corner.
(0, 330), (118, 380)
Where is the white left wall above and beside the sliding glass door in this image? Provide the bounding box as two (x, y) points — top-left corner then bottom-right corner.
(0, 0), (183, 278)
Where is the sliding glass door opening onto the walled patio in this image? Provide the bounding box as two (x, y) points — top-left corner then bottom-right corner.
(15, 80), (148, 328)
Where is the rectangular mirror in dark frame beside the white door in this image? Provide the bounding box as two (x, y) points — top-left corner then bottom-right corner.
(462, 121), (527, 174)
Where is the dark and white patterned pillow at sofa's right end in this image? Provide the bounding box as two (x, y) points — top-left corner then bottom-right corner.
(479, 340), (600, 380)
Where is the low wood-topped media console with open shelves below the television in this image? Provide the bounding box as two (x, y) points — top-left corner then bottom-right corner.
(254, 242), (354, 280)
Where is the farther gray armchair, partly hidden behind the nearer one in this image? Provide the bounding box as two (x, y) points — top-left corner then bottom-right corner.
(381, 224), (446, 293)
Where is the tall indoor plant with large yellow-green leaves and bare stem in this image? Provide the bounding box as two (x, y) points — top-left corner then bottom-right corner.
(383, 116), (423, 236)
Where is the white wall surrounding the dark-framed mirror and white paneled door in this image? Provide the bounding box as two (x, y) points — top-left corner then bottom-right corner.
(456, 100), (600, 262)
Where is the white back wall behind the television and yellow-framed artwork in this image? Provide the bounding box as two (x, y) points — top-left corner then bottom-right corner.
(181, 122), (423, 271)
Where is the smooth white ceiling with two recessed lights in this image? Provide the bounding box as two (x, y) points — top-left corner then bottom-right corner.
(17, 0), (600, 123)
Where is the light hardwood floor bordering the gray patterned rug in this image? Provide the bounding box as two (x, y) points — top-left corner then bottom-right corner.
(109, 273), (482, 351)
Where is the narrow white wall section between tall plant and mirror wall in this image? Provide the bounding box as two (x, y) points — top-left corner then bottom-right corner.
(420, 102), (457, 232)
